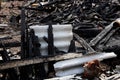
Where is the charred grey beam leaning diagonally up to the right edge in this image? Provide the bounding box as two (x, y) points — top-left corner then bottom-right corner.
(89, 18), (120, 47)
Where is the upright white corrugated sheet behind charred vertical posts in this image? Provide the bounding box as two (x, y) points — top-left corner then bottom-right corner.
(30, 24), (73, 55)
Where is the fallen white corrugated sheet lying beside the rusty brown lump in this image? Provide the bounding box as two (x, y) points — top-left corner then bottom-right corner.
(54, 52), (117, 76)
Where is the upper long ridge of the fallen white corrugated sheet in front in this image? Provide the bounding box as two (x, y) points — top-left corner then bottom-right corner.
(54, 52), (117, 69)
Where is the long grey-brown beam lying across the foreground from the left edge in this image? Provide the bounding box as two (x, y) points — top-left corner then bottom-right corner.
(0, 53), (82, 70)
